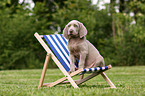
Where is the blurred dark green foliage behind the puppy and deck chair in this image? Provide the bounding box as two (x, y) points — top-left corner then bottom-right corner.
(0, 0), (145, 69)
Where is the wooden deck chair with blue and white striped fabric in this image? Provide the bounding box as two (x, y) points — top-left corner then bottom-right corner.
(34, 33), (116, 88)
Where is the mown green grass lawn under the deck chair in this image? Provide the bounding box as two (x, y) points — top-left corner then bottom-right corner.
(0, 66), (145, 96)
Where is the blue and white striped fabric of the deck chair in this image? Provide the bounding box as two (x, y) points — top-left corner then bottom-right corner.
(43, 34), (108, 74)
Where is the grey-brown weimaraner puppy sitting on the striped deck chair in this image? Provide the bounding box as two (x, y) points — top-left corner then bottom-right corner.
(63, 20), (105, 72)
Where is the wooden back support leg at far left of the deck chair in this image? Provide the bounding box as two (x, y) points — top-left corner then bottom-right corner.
(38, 53), (50, 88)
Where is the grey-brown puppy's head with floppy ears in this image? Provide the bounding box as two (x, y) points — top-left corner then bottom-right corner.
(63, 20), (87, 39)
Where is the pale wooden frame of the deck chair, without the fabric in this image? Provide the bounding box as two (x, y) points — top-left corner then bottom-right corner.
(34, 33), (116, 88)
